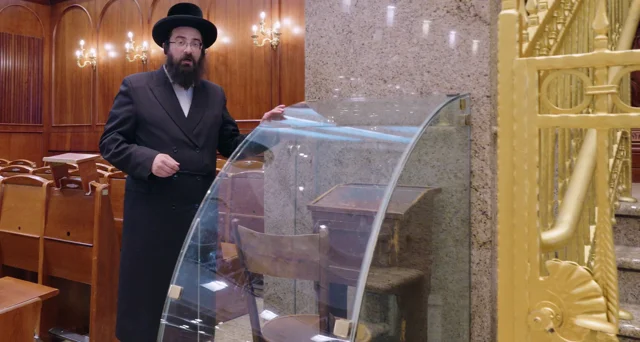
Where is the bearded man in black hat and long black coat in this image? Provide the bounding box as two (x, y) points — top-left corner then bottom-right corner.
(97, 3), (284, 342)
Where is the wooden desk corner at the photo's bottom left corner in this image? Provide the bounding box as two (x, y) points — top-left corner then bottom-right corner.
(0, 277), (58, 342)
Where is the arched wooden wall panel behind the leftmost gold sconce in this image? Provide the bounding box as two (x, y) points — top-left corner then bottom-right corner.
(51, 4), (96, 126)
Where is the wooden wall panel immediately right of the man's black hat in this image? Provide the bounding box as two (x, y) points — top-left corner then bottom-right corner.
(207, 0), (275, 120)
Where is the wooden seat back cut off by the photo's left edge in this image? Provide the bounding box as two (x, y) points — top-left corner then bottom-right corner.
(0, 175), (53, 283)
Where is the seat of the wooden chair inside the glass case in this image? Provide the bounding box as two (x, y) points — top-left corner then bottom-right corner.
(262, 315), (371, 342)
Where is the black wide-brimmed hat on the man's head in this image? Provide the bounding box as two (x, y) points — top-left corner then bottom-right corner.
(151, 2), (218, 49)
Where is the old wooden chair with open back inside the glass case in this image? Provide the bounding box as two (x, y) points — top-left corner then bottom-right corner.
(233, 226), (371, 342)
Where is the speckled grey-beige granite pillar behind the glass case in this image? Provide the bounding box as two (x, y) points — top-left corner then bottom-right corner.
(304, 0), (499, 341)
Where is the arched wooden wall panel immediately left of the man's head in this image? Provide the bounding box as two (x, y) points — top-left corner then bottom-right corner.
(95, 0), (144, 125)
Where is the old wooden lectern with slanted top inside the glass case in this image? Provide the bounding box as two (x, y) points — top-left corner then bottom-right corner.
(307, 184), (441, 341)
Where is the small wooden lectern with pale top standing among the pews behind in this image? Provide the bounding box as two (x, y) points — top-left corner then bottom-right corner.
(42, 153), (100, 194)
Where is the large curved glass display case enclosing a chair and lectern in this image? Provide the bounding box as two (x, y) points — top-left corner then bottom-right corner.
(159, 95), (469, 342)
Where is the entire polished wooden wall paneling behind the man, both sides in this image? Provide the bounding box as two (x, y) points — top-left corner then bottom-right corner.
(0, 0), (304, 155)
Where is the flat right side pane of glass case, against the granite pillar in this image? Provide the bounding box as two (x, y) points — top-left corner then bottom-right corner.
(354, 96), (471, 342)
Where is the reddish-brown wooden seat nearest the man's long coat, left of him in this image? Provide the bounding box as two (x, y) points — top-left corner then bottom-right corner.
(43, 178), (120, 341)
